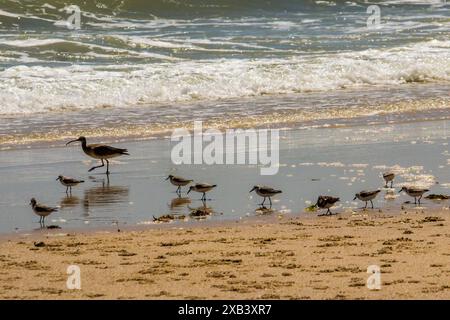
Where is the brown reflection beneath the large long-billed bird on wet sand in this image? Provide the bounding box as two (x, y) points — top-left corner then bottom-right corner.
(83, 176), (129, 215)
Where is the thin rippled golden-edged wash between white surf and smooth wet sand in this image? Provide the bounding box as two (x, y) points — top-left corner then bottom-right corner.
(0, 83), (449, 151)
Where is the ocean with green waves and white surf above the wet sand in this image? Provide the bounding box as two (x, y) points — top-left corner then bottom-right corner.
(0, 0), (450, 147)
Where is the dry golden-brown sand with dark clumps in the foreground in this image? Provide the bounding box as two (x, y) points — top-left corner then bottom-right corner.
(0, 210), (450, 299)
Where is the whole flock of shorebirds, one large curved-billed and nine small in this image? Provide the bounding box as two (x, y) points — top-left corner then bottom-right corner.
(30, 137), (429, 224)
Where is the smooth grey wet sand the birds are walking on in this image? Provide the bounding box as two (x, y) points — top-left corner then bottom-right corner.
(0, 121), (450, 233)
